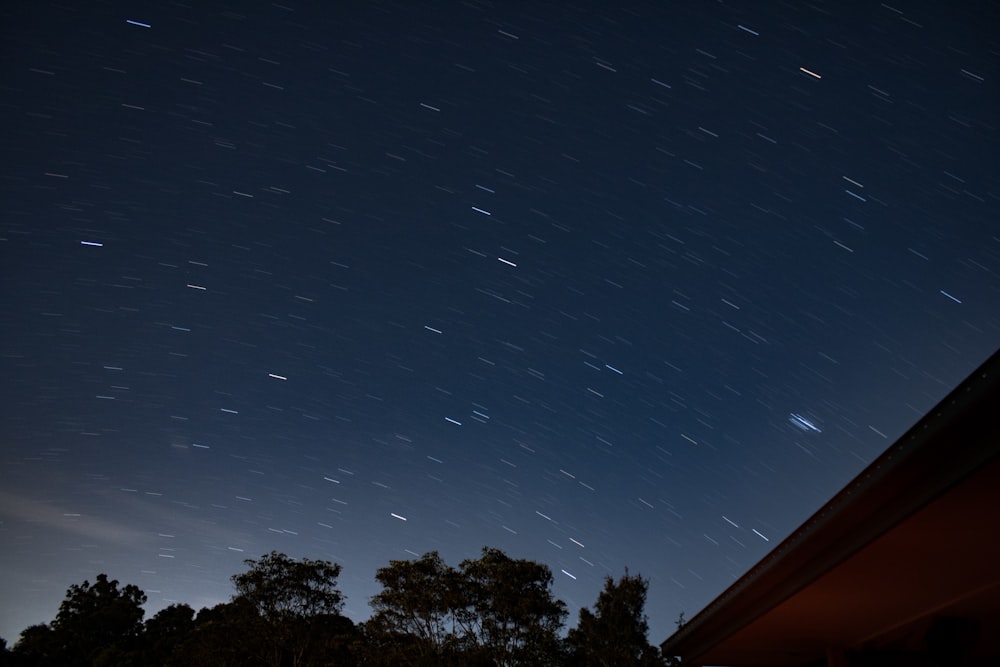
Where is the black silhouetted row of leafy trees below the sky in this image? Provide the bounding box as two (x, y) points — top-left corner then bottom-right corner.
(0, 548), (670, 667)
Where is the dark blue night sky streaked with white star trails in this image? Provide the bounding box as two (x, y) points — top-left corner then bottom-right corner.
(0, 0), (1000, 642)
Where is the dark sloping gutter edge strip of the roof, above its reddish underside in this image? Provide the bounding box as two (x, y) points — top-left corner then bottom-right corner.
(661, 351), (1000, 659)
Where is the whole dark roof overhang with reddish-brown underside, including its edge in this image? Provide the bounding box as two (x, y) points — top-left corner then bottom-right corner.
(662, 352), (1000, 667)
